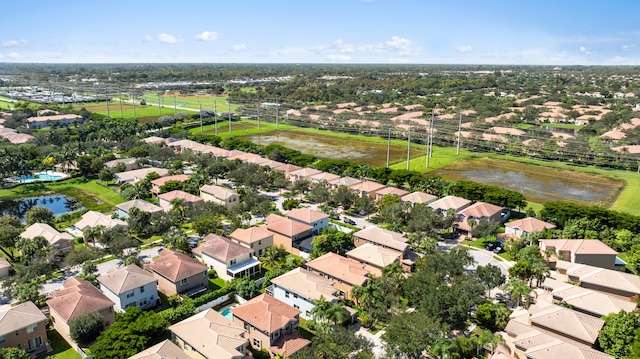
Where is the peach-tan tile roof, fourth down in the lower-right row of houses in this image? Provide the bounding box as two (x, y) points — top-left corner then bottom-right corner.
(529, 301), (604, 344)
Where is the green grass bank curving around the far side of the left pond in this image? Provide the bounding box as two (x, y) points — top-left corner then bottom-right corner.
(0, 178), (123, 211)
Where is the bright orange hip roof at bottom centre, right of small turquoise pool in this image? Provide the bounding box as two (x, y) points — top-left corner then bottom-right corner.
(231, 294), (300, 333)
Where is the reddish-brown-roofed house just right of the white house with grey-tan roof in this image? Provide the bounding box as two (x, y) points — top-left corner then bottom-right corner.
(145, 249), (209, 297)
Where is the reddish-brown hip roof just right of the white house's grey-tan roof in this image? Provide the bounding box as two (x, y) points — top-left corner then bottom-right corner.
(147, 249), (207, 282)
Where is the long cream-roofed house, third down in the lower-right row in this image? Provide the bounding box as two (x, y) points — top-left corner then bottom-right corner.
(538, 278), (638, 318)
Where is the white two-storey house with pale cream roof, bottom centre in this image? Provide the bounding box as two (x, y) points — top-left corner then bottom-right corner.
(267, 268), (339, 319)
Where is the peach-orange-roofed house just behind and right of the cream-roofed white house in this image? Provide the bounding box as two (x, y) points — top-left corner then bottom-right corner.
(306, 252), (370, 299)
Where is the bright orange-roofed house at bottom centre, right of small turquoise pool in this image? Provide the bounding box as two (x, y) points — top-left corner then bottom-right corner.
(231, 294), (311, 356)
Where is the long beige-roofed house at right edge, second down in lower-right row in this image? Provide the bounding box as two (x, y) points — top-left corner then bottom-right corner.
(555, 260), (640, 299)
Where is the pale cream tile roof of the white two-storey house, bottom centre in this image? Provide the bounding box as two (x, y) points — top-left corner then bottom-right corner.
(271, 268), (338, 301)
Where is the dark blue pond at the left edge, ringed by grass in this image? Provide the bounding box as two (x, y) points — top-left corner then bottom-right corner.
(0, 194), (82, 220)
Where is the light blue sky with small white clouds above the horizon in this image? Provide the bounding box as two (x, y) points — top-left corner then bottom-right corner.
(0, 0), (640, 65)
